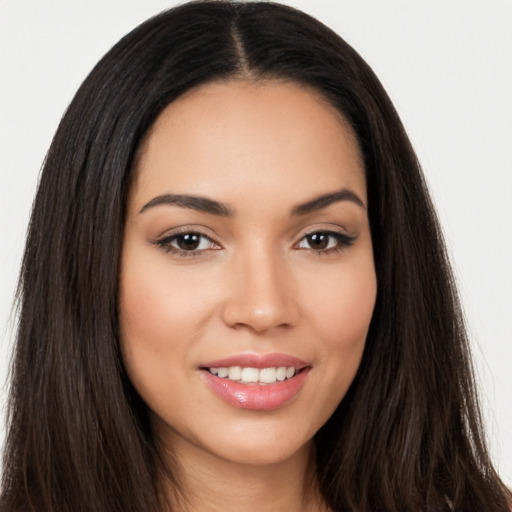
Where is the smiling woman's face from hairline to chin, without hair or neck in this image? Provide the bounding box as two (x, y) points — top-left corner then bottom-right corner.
(119, 82), (376, 464)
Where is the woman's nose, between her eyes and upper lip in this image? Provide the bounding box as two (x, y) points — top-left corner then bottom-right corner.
(223, 247), (299, 333)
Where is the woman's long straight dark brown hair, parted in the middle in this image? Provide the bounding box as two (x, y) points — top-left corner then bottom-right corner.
(0, 1), (510, 512)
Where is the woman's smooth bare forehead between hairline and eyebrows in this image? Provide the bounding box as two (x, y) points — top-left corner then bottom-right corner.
(132, 81), (366, 210)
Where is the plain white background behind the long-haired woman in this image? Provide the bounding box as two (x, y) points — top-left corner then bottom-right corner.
(0, 0), (512, 485)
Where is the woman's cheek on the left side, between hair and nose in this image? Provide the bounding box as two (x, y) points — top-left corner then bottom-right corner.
(119, 254), (215, 402)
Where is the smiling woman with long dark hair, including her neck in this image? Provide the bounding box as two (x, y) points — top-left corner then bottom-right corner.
(1, 2), (510, 512)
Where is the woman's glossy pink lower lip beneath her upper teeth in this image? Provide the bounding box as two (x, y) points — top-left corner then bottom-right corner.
(201, 367), (311, 411)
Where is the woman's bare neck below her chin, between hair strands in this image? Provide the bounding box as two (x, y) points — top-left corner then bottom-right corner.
(159, 436), (328, 512)
